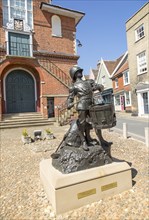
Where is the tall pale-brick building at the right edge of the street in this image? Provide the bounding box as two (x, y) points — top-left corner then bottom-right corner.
(126, 3), (149, 116)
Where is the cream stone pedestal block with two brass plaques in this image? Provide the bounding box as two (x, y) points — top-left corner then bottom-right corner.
(40, 159), (132, 214)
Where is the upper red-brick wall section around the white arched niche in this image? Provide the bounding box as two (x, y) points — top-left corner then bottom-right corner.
(34, 1), (76, 54)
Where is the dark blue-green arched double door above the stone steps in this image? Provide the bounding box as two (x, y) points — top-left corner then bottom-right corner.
(6, 69), (35, 113)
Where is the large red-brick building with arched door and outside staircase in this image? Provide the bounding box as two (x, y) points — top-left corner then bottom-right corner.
(0, 0), (85, 119)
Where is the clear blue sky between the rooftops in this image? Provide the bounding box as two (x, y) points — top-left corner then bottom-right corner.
(52, 0), (148, 74)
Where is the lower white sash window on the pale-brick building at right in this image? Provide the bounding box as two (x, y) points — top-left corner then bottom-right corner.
(137, 51), (147, 74)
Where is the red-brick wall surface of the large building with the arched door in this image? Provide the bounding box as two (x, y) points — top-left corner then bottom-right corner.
(0, 0), (79, 117)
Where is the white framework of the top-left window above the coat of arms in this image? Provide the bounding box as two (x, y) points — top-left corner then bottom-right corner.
(3, 0), (33, 29)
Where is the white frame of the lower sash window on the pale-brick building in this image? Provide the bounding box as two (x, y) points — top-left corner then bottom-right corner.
(137, 50), (147, 75)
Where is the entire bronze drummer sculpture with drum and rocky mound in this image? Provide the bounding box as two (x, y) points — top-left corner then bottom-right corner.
(52, 66), (116, 173)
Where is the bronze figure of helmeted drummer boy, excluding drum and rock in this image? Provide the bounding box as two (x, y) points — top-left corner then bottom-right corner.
(67, 66), (104, 150)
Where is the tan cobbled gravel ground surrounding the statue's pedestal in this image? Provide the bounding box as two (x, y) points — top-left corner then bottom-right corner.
(0, 124), (149, 220)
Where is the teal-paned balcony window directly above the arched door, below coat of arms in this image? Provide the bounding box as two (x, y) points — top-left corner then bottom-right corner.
(8, 33), (31, 56)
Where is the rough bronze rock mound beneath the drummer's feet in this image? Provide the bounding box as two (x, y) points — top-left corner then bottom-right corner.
(52, 145), (112, 174)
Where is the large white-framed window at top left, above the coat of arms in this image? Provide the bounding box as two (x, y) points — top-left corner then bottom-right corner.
(3, 0), (33, 28)
